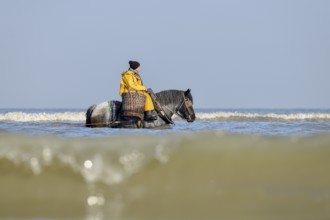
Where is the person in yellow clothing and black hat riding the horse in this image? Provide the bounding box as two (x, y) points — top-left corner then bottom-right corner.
(119, 61), (157, 121)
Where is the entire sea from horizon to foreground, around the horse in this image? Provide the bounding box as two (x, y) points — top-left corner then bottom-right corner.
(0, 109), (330, 220)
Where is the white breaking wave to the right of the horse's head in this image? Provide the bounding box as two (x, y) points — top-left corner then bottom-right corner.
(197, 112), (330, 121)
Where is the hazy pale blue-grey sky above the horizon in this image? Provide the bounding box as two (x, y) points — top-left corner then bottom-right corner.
(0, 0), (330, 108)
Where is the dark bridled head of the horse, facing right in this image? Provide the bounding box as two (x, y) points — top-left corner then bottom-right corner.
(176, 89), (196, 122)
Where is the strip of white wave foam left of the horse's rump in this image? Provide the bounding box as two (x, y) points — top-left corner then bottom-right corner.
(0, 112), (86, 122)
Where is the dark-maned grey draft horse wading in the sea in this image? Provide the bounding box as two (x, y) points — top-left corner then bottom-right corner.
(85, 89), (195, 128)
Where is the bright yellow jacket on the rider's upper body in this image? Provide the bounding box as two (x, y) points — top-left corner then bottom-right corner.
(119, 70), (147, 96)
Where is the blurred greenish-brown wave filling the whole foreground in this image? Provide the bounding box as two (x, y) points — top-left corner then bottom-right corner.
(0, 132), (330, 220)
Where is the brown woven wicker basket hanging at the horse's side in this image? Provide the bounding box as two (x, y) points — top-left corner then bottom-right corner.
(122, 92), (146, 120)
